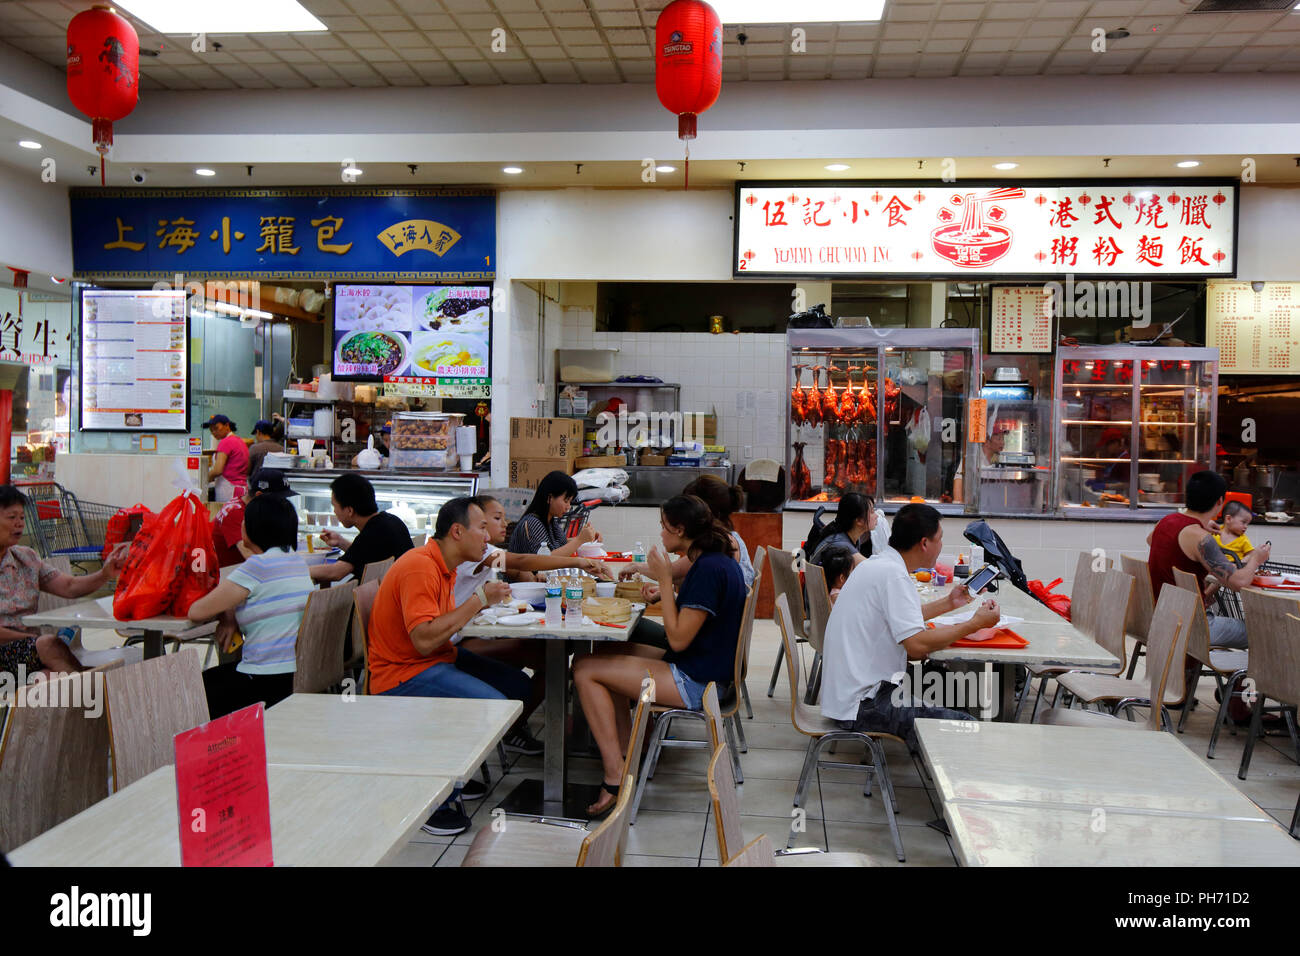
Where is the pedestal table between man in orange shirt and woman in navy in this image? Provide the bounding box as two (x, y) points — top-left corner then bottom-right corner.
(460, 605), (644, 819)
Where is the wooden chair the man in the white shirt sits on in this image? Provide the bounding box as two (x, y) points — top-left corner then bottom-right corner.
(769, 594), (906, 862)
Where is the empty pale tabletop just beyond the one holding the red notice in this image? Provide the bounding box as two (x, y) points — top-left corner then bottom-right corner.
(265, 693), (524, 784)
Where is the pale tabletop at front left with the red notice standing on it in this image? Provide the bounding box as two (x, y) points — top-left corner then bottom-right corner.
(9, 764), (451, 866)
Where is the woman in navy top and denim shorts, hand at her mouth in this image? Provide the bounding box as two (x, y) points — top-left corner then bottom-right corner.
(573, 494), (748, 817)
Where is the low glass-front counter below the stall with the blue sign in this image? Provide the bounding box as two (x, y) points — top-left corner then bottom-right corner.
(285, 470), (478, 544)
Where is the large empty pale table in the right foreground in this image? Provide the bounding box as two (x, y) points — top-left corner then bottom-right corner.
(917, 719), (1300, 866)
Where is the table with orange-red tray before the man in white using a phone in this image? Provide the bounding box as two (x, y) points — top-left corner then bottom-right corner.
(920, 584), (1119, 721)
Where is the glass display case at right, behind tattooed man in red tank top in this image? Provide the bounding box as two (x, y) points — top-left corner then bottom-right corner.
(1057, 346), (1218, 516)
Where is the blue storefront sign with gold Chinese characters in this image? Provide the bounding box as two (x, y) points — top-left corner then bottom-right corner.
(70, 186), (497, 282)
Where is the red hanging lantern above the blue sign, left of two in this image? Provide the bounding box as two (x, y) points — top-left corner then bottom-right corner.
(68, 7), (140, 182)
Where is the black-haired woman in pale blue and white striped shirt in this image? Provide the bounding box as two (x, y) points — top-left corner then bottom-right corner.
(190, 494), (315, 717)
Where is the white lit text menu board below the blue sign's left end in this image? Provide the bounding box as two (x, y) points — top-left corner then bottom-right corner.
(79, 289), (190, 432)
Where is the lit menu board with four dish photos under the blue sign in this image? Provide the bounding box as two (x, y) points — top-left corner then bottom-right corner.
(334, 285), (491, 398)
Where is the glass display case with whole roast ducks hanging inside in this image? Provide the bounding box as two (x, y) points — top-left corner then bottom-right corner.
(787, 328), (979, 512)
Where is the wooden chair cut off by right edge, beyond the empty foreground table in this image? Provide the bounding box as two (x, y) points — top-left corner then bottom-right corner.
(1236, 588), (1300, 785)
